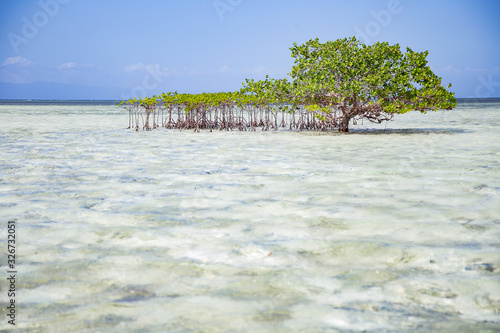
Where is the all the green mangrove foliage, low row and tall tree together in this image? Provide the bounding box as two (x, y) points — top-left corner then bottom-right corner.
(120, 37), (456, 132)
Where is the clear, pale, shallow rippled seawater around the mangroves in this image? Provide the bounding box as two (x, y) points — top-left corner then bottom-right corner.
(0, 100), (500, 332)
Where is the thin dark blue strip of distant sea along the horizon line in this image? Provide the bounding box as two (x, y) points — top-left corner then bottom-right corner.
(0, 97), (500, 105)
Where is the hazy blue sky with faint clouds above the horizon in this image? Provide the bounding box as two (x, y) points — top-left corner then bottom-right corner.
(0, 0), (500, 99)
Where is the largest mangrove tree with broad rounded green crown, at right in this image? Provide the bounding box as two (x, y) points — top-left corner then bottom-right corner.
(284, 37), (456, 131)
